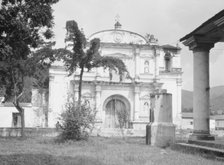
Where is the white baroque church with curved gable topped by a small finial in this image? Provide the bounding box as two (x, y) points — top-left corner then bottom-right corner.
(48, 21), (182, 134)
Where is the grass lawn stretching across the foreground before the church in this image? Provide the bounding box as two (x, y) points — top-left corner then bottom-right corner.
(0, 137), (224, 165)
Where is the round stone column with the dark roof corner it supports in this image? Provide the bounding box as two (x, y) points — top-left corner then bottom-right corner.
(180, 10), (224, 140)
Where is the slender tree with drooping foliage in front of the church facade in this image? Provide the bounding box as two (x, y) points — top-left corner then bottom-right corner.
(64, 20), (128, 106)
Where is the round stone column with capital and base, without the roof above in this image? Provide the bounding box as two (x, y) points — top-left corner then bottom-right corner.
(189, 43), (214, 140)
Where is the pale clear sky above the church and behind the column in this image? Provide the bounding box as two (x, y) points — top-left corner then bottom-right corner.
(53, 0), (224, 90)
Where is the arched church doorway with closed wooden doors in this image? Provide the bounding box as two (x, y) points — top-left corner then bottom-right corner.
(104, 96), (130, 128)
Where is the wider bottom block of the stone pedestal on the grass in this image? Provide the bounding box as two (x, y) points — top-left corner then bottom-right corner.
(151, 123), (175, 147)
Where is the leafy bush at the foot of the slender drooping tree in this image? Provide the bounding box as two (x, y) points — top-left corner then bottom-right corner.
(59, 102), (96, 141)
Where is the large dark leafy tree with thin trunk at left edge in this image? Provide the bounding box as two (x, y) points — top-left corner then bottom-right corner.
(0, 0), (58, 136)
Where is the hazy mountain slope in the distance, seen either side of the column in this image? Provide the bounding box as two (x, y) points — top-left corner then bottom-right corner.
(182, 86), (224, 112)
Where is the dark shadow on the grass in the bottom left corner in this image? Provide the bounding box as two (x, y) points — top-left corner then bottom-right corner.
(0, 154), (103, 165)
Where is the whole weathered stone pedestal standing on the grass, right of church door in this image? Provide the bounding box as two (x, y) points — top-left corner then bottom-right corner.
(151, 93), (175, 147)
